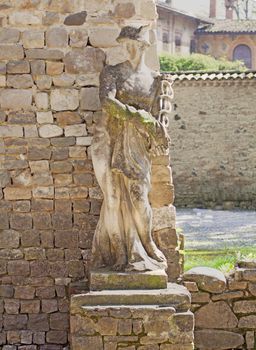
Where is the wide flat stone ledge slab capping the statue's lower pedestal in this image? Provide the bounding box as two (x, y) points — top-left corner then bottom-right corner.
(71, 283), (191, 313)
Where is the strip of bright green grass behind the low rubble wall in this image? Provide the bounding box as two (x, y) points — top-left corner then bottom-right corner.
(185, 248), (256, 273)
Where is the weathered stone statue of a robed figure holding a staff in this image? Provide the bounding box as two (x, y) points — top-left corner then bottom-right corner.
(92, 28), (172, 272)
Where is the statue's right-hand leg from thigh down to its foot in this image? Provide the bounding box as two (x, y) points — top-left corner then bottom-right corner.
(129, 180), (166, 262)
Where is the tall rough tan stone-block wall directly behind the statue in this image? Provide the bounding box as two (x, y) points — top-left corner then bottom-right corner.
(0, 0), (184, 350)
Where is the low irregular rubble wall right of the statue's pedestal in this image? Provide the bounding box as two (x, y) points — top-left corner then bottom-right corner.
(184, 261), (256, 350)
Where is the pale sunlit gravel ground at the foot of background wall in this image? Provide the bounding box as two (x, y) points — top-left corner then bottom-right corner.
(177, 209), (256, 250)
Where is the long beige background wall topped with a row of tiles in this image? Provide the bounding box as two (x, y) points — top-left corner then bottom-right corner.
(164, 73), (256, 209)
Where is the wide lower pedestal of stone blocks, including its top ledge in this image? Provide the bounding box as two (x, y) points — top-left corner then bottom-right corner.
(70, 285), (194, 350)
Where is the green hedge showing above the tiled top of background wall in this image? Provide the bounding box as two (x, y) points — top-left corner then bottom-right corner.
(160, 53), (246, 72)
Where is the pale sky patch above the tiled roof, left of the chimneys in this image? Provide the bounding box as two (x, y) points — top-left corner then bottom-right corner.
(172, 0), (210, 17)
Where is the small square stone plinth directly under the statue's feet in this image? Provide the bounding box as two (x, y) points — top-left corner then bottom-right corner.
(90, 269), (167, 291)
